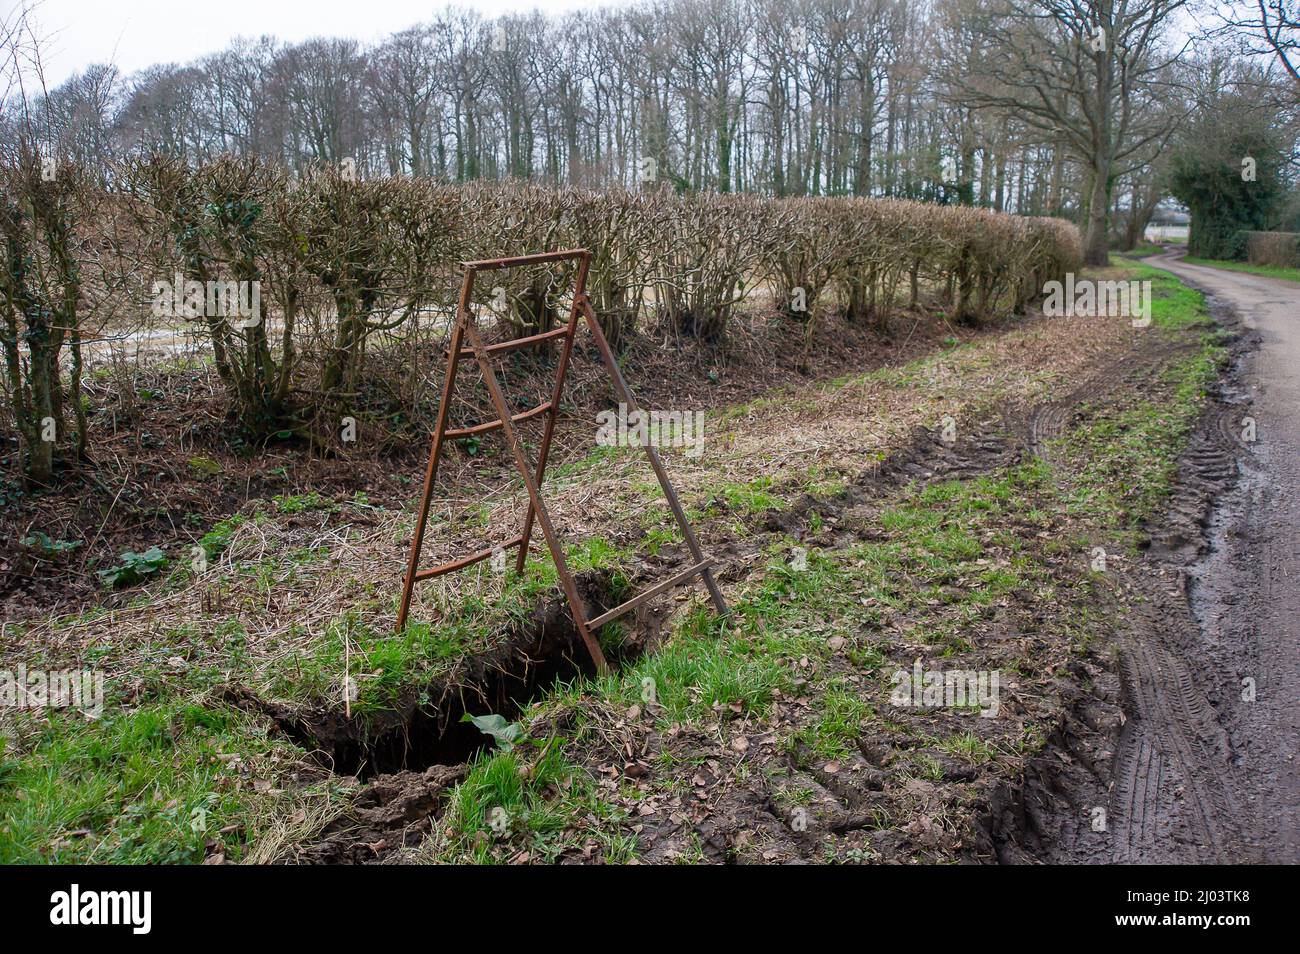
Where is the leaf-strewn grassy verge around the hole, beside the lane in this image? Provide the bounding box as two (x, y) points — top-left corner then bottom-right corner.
(0, 266), (1223, 863)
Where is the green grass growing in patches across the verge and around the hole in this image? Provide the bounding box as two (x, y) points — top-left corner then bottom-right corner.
(0, 266), (1223, 863)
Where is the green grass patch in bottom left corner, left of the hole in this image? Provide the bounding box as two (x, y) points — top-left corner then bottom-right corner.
(0, 699), (309, 864)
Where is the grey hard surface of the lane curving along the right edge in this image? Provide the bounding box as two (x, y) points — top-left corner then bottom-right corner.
(1149, 255), (1300, 864)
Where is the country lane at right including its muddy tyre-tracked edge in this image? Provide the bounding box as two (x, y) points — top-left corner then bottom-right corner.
(1128, 253), (1300, 863)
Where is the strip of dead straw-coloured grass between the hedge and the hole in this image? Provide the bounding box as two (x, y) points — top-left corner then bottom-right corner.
(4, 306), (1132, 717)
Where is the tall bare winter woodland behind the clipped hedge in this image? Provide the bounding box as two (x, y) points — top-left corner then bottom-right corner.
(0, 0), (1300, 265)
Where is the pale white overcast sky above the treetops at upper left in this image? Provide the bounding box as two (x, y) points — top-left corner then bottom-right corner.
(10, 0), (627, 88)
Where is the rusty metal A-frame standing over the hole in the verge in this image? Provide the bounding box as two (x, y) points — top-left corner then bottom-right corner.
(397, 248), (728, 673)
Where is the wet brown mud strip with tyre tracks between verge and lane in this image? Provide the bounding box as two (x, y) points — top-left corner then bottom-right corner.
(988, 267), (1300, 864)
